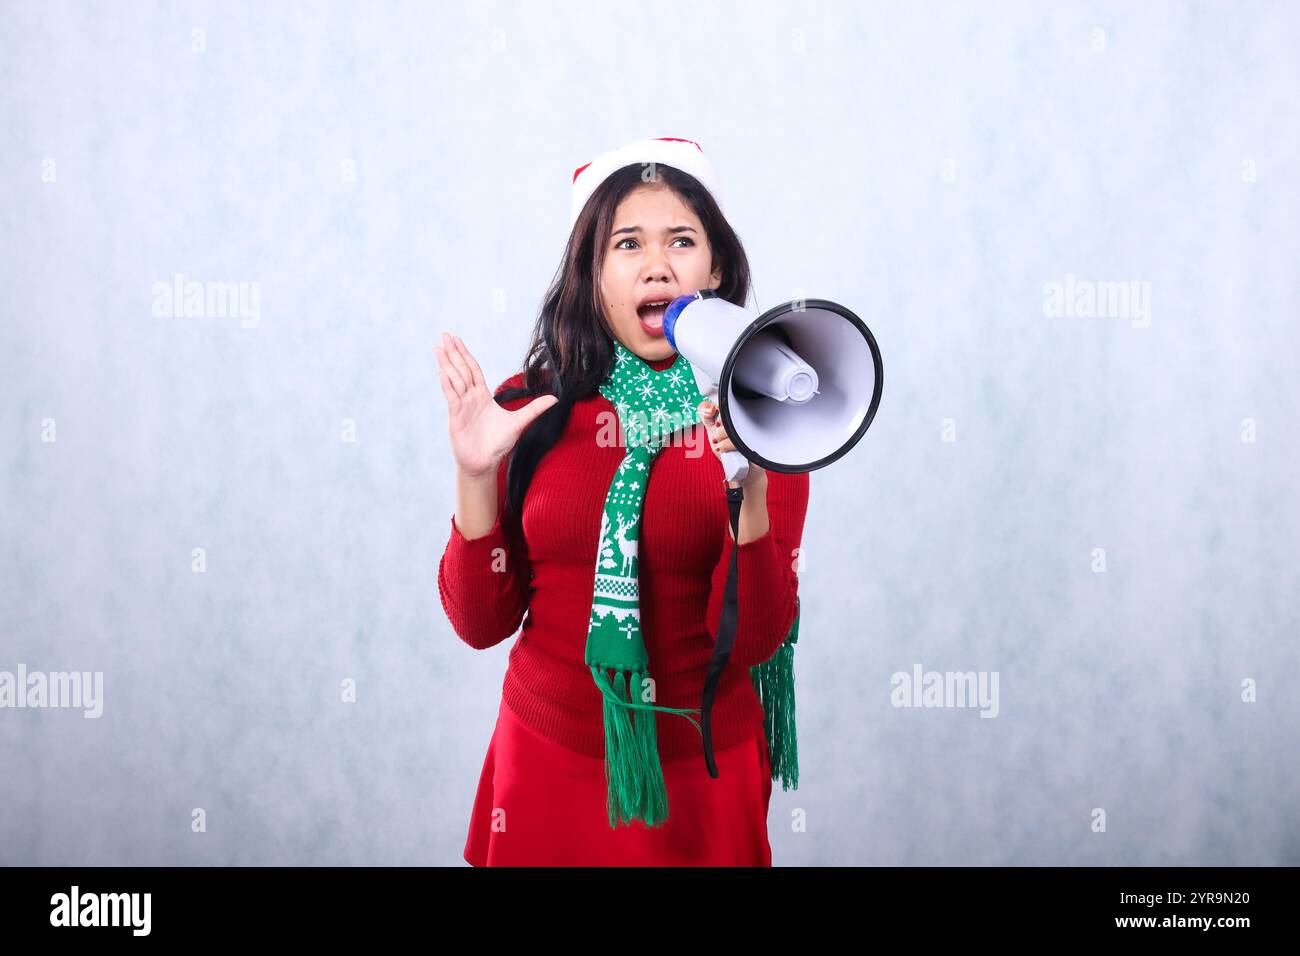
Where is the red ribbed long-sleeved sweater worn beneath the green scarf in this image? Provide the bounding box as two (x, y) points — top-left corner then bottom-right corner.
(438, 356), (809, 760)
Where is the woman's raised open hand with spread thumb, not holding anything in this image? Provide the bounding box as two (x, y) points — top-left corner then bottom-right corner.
(433, 332), (559, 479)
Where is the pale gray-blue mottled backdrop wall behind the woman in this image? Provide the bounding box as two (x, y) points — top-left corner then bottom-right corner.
(0, 3), (1300, 865)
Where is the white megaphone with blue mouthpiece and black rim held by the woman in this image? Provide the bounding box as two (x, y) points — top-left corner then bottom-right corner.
(663, 289), (884, 481)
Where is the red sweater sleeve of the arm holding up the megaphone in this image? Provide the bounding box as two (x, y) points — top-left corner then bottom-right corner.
(706, 471), (809, 667)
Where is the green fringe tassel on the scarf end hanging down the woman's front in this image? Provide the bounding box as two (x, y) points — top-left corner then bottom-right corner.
(592, 666), (703, 830)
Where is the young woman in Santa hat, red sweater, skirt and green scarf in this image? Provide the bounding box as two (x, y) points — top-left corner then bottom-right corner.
(434, 139), (809, 866)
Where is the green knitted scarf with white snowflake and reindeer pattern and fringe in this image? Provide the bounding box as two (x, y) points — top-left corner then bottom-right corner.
(584, 339), (800, 829)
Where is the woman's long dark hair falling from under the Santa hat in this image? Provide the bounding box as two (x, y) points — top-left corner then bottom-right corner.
(494, 163), (750, 515)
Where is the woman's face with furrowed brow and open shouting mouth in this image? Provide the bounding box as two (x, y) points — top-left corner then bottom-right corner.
(601, 185), (723, 362)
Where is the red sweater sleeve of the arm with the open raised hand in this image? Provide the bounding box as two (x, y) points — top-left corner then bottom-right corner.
(438, 374), (533, 649)
